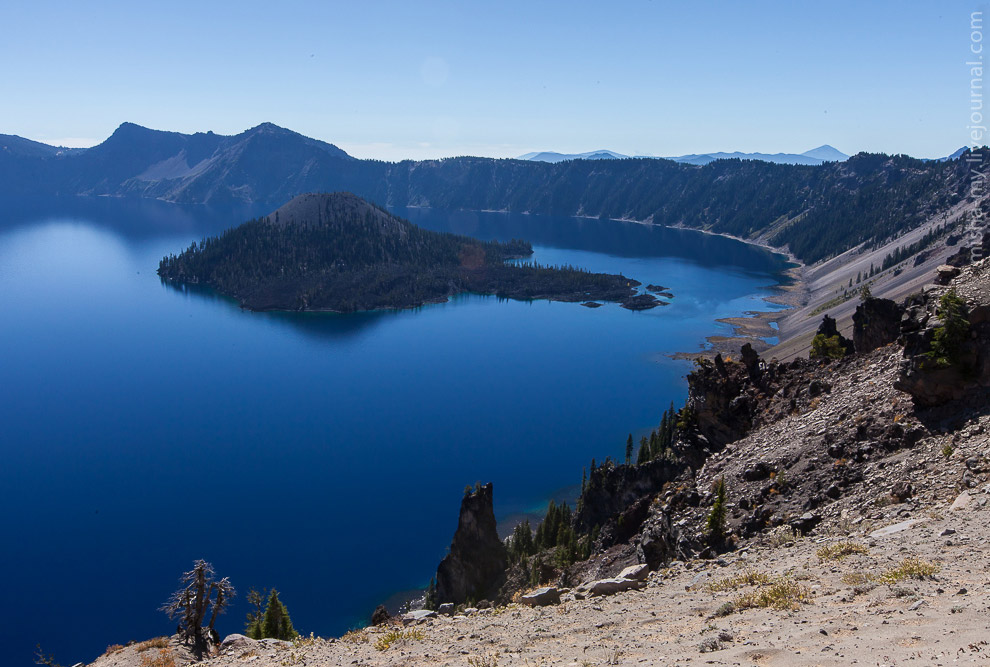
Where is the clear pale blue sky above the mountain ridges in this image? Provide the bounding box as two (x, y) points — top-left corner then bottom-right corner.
(0, 0), (990, 159)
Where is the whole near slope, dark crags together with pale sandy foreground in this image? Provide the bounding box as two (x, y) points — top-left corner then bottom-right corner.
(87, 260), (990, 667)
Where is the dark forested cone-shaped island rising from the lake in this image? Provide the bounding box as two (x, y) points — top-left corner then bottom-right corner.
(158, 193), (662, 313)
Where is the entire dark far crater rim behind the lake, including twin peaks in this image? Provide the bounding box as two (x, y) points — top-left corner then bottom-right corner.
(0, 123), (990, 262)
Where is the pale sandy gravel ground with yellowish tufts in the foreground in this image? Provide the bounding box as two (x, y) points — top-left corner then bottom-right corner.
(134, 494), (990, 667)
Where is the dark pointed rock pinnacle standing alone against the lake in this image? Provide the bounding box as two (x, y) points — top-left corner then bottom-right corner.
(437, 483), (508, 604)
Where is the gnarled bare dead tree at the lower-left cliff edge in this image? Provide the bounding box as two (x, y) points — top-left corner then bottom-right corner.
(161, 560), (234, 649)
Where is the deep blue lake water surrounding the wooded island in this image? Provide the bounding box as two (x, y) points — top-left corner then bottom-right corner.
(0, 199), (783, 664)
